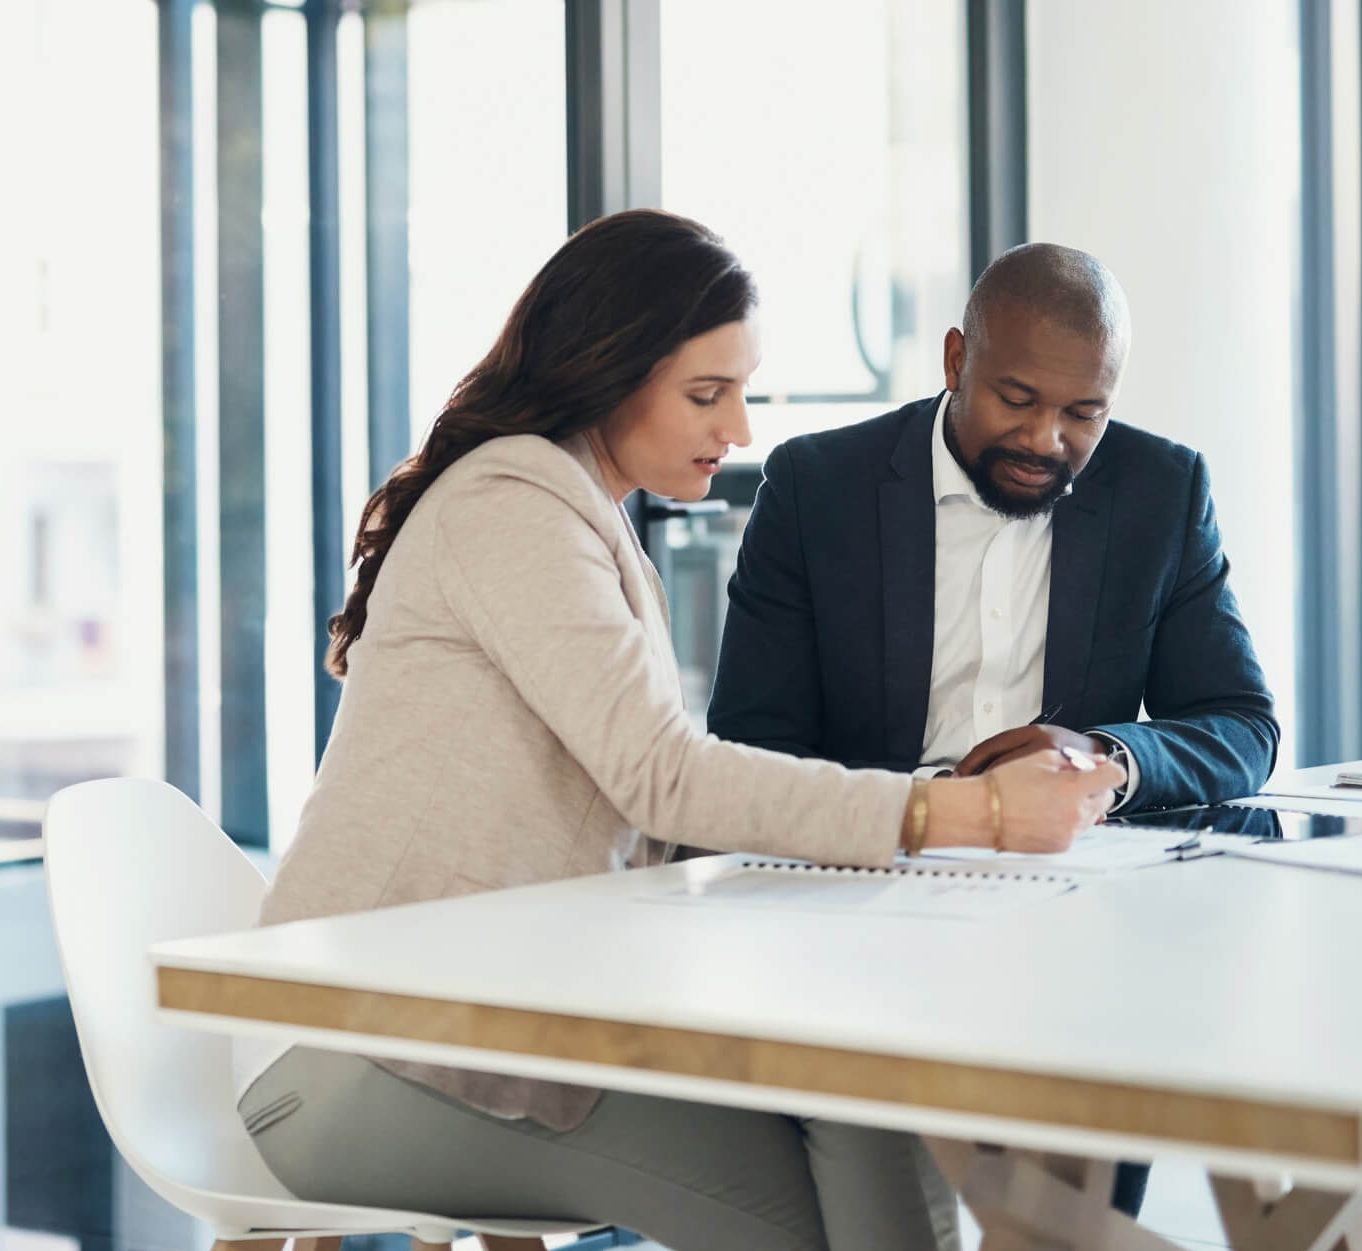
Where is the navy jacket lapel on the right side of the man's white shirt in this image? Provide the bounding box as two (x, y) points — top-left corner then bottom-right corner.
(1042, 451), (1111, 730)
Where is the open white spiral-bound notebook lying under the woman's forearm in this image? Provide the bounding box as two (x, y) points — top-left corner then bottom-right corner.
(650, 859), (1079, 920)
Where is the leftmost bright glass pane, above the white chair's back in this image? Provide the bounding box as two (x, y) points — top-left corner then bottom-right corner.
(0, 0), (162, 824)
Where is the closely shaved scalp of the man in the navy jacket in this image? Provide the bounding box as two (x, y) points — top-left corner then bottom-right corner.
(963, 244), (1130, 358)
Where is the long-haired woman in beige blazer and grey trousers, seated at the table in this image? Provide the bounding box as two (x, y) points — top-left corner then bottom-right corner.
(238, 211), (1122, 1251)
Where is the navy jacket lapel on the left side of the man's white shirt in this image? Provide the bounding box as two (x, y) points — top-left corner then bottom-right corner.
(880, 402), (937, 764)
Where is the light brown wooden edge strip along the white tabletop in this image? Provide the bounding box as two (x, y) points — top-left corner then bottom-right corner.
(157, 965), (1362, 1167)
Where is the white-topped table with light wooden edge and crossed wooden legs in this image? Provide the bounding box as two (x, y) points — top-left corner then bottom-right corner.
(153, 858), (1362, 1251)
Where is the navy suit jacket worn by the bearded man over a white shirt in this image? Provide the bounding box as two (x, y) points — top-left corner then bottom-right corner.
(710, 396), (1279, 807)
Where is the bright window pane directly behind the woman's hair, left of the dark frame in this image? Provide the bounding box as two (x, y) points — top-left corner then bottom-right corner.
(410, 0), (568, 441)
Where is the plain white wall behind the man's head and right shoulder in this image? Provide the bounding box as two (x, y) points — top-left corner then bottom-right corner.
(1027, 0), (1299, 764)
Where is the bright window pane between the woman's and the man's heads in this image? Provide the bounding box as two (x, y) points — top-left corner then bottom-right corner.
(662, 0), (968, 453)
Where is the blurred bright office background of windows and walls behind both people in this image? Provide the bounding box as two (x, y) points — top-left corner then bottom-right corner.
(0, 0), (1362, 1246)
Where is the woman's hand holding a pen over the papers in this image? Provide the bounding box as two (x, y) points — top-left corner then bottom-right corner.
(987, 751), (1125, 852)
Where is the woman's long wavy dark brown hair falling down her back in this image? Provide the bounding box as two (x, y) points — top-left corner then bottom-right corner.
(327, 210), (756, 678)
